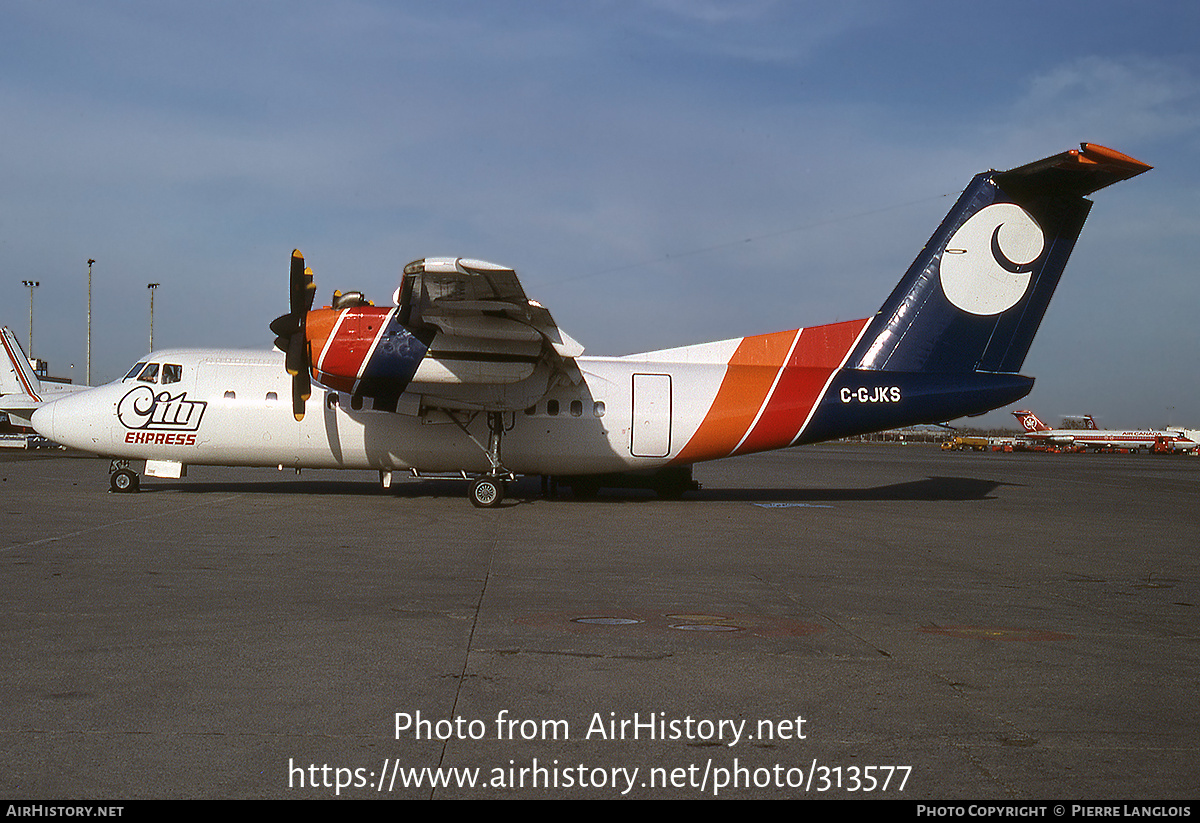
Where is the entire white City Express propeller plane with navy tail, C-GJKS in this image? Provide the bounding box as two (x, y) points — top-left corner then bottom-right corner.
(32, 144), (1150, 506)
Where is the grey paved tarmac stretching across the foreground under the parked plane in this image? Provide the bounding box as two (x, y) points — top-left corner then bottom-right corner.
(0, 444), (1200, 801)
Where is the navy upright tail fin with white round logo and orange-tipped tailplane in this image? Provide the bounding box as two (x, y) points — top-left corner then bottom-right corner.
(847, 143), (1150, 374)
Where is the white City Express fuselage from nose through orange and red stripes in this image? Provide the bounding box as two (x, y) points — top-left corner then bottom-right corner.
(35, 320), (865, 475)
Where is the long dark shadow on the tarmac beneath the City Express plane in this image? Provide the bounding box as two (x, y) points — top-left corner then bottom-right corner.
(140, 477), (1013, 507)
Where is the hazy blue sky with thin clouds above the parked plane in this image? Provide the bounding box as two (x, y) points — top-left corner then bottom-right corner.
(0, 0), (1200, 427)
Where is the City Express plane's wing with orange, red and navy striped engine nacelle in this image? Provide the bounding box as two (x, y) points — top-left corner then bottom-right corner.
(306, 258), (583, 414)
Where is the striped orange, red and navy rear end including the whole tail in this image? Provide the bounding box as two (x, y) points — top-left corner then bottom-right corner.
(674, 143), (1150, 463)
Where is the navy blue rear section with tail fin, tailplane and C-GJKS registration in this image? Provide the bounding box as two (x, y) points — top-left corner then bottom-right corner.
(796, 143), (1151, 443)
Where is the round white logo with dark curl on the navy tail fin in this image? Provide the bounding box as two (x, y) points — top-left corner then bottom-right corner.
(941, 203), (1045, 314)
